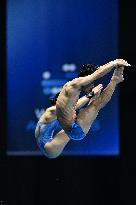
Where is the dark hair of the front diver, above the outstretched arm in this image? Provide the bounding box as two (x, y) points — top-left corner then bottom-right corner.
(78, 64), (99, 77)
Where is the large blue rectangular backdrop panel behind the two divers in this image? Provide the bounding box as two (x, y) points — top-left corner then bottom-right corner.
(7, 0), (119, 155)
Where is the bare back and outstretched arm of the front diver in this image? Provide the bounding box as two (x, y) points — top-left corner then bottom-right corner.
(56, 59), (129, 133)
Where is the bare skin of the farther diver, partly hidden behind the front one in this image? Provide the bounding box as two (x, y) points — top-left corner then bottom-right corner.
(35, 84), (103, 158)
